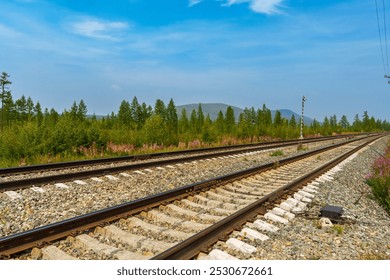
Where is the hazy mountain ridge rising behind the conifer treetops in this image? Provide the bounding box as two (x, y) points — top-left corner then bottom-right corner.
(176, 103), (313, 124)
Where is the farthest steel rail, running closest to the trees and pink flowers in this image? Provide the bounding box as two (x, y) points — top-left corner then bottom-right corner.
(0, 134), (365, 176)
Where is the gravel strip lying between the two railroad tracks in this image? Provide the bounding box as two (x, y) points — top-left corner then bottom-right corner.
(0, 141), (346, 237)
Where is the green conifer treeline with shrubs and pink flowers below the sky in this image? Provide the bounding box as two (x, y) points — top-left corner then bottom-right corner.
(0, 72), (390, 167)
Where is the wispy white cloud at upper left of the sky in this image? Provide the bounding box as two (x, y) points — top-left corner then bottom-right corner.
(70, 18), (129, 41)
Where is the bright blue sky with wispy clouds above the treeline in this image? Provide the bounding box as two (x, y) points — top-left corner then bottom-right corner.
(0, 0), (390, 122)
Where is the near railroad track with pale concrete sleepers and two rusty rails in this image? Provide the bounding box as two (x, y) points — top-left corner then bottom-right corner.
(0, 134), (377, 259)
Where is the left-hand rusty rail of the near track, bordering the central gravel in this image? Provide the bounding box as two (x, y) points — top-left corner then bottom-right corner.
(0, 136), (379, 257)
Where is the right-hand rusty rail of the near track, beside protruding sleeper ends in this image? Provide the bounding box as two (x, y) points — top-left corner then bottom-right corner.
(152, 136), (376, 260)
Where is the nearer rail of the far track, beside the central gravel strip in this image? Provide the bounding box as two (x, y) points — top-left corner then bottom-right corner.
(0, 136), (369, 191)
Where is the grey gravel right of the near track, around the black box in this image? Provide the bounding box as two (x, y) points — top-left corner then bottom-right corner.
(250, 137), (390, 260)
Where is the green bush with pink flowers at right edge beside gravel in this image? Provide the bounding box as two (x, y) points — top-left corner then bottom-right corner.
(366, 141), (390, 215)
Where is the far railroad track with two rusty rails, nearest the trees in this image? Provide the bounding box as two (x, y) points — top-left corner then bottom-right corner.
(0, 135), (364, 192)
